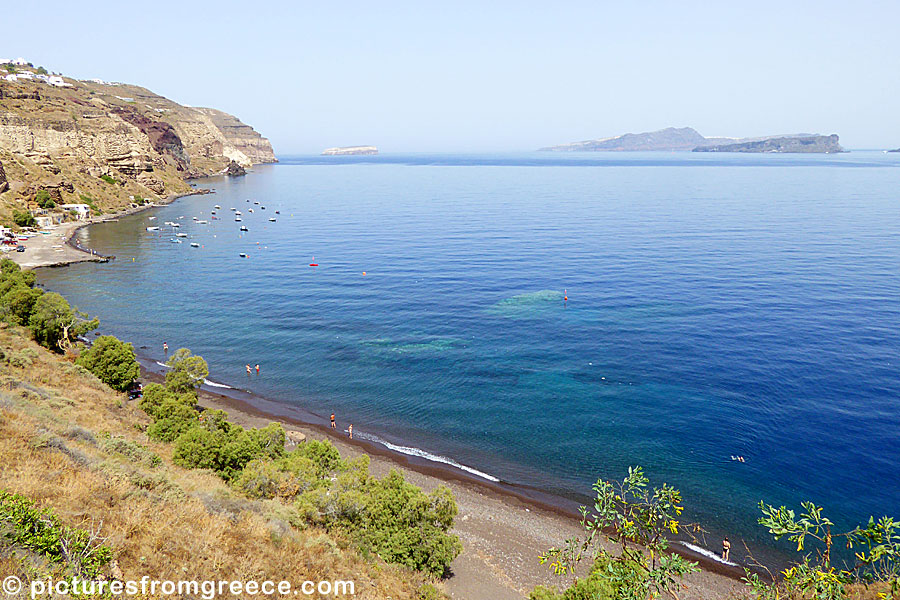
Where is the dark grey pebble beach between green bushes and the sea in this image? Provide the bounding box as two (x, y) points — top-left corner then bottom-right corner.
(137, 369), (744, 600)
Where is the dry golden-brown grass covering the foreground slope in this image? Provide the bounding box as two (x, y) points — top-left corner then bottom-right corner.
(0, 328), (436, 599)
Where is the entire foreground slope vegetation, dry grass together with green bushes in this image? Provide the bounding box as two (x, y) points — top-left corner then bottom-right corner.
(0, 261), (450, 599)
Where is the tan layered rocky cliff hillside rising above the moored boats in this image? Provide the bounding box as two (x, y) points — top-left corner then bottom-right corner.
(0, 66), (276, 224)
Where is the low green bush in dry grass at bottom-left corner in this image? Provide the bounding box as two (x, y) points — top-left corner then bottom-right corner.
(0, 490), (112, 578)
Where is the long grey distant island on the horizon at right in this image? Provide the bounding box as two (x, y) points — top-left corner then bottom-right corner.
(540, 127), (844, 153)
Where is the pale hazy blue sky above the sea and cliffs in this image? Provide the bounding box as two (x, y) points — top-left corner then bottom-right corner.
(0, 0), (900, 154)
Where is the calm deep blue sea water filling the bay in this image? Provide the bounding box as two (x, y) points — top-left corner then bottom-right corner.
(39, 152), (900, 556)
